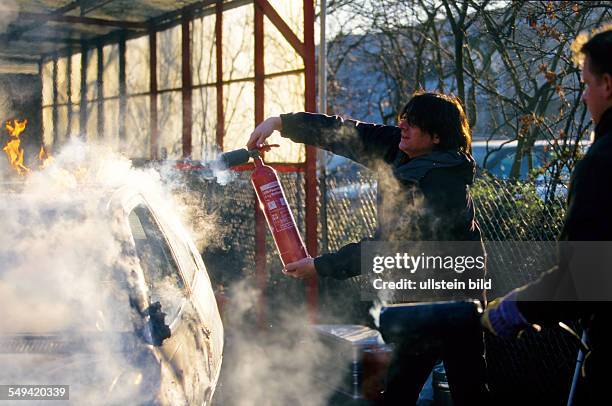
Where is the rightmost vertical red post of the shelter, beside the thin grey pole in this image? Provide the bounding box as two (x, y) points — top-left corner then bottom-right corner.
(303, 0), (319, 323)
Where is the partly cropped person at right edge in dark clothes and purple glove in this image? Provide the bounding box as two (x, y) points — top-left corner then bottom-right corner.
(482, 26), (612, 404)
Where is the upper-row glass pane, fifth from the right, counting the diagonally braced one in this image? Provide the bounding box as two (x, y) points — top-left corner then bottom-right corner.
(125, 35), (150, 94)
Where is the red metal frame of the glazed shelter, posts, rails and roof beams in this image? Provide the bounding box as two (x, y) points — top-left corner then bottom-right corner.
(0, 0), (318, 325)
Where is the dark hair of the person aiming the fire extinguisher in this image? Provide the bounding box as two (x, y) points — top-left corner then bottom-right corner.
(399, 92), (472, 154)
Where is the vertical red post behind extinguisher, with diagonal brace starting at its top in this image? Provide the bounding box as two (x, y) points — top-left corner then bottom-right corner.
(254, 0), (267, 329)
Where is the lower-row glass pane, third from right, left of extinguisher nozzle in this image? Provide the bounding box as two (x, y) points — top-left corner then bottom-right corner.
(192, 87), (217, 161)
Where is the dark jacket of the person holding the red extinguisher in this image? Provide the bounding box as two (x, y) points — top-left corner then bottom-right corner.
(281, 113), (481, 279)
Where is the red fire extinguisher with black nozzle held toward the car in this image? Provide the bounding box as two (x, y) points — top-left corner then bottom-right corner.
(221, 145), (308, 265)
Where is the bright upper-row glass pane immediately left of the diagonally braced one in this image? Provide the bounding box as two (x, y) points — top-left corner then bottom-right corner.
(223, 4), (255, 80)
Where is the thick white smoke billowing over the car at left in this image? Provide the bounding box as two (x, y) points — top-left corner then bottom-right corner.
(0, 141), (208, 404)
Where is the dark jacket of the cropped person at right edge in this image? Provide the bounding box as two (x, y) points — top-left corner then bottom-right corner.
(517, 108), (612, 405)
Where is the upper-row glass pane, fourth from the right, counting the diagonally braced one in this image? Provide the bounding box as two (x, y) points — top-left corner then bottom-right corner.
(157, 26), (182, 90)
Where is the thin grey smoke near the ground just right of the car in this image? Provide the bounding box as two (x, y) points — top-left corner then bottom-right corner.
(217, 281), (342, 406)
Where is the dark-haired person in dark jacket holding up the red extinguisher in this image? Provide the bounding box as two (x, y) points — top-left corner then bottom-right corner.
(247, 93), (486, 405)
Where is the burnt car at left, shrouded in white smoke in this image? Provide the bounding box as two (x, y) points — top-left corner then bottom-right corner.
(0, 182), (223, 405)
